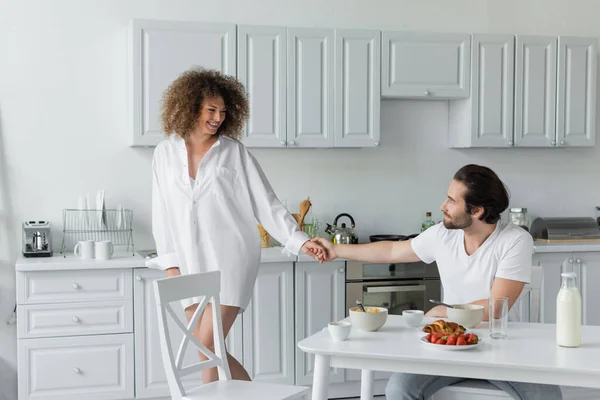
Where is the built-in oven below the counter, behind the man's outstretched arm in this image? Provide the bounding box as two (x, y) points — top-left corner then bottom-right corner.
(346, 261), (442, 316)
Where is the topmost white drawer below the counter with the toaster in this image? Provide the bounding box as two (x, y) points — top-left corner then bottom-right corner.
(17, 269), (133, 304)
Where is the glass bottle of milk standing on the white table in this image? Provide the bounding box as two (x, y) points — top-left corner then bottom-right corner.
(556, 272), (581, 347)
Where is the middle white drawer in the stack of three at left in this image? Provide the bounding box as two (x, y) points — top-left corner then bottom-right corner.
(17, 300), (133, 338)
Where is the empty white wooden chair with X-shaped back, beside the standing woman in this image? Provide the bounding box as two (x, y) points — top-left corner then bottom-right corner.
(154, 271), (309, 400)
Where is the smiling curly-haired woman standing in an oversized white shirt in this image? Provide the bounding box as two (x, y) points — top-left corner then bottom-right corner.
(148, 68), (323, 383)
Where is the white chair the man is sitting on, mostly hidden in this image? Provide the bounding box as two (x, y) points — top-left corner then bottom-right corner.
(429, 265), (544, 400)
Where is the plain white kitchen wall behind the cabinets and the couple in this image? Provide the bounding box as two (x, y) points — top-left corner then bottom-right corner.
(0, 0), (600, 399)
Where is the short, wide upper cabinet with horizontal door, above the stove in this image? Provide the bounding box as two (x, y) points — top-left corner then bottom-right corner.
(381, 31), (471, 99)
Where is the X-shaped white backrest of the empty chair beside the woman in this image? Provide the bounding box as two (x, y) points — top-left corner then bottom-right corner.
(154, 271), (231, 399)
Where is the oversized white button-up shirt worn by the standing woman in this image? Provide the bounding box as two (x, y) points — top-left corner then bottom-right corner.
(146, 136), (309, 312)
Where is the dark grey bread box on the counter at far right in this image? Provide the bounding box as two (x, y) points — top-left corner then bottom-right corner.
(530, 217), (600, 243)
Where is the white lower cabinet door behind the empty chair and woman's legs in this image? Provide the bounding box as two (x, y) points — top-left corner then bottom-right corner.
(133, 268), (242, 399)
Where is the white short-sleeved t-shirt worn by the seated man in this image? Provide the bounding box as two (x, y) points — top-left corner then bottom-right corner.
(411, 221), (533, 304)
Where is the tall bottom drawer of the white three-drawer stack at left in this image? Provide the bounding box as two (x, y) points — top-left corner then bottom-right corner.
(18, 334), (134, 400)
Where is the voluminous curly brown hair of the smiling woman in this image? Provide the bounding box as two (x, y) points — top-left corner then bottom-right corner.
(161, 67), (250, 139)
